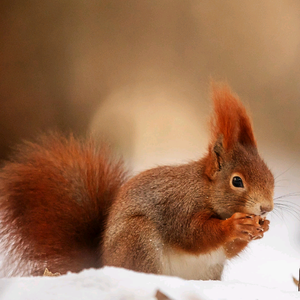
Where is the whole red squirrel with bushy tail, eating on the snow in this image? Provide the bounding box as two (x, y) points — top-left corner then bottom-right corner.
(0, 86), (274, 280)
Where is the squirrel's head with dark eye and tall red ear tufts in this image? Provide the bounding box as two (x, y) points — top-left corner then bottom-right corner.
(204, 86), (274, 219)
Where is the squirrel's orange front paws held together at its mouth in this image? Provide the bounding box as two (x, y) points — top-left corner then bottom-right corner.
(224, 213), (269, 242)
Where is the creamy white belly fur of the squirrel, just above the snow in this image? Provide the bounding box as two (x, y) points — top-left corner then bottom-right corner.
(162, 248), (226, 280)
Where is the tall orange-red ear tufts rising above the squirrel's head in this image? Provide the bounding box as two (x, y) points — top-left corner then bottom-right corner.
(211, 84), (256, 150)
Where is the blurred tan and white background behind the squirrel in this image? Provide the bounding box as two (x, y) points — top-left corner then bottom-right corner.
(0, 0), (300, 285)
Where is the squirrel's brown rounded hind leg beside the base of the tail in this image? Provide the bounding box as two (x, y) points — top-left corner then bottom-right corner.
(102, 216), (163, 274)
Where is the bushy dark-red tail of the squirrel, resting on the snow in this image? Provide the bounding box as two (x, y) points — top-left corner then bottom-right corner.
(0, 134), (126, 275)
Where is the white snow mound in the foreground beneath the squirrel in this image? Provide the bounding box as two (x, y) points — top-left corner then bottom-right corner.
(0, 267), (300, 300)
